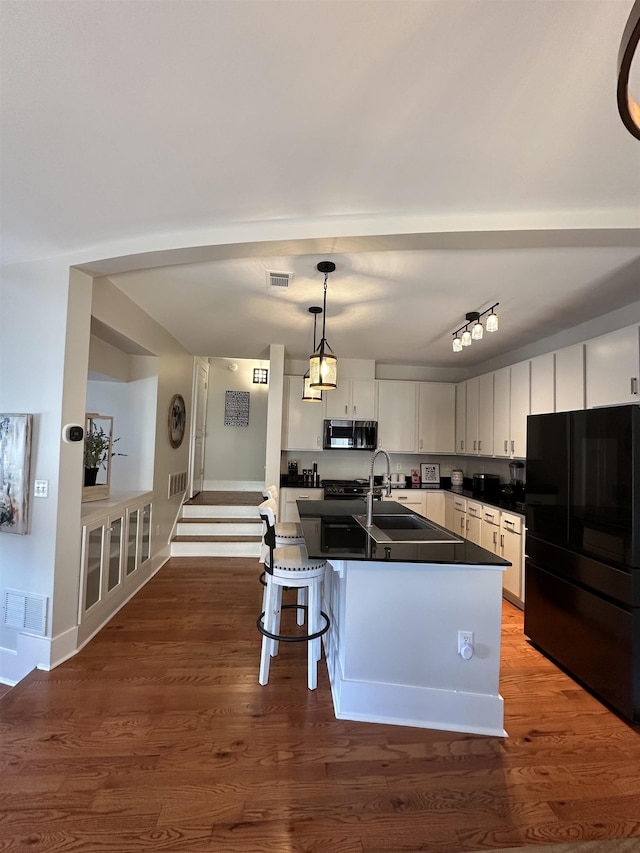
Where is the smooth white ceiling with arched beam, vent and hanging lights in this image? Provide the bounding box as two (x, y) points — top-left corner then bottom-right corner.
(0, 0), (640, 367)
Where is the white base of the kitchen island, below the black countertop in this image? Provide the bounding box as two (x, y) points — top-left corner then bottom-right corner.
(324, 560), (506, 736)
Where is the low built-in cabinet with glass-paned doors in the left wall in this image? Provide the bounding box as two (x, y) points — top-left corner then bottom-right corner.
(78, 495), (152, 623)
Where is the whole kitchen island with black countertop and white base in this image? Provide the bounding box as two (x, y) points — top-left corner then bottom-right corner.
(298, 500), (509, 735)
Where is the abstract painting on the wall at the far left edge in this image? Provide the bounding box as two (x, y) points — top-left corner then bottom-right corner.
(0, 415), (33, 534)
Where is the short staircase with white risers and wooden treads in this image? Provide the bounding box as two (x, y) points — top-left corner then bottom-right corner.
(171, 492), (264, 557)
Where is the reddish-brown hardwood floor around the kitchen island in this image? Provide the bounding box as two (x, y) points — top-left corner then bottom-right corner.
(0, 558), (640, 853)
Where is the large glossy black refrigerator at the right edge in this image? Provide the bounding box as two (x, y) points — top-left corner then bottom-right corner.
(524, 405), (640, 723)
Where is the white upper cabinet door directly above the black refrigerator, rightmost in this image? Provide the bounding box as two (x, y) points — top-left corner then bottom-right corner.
(585, 326), (640, 409)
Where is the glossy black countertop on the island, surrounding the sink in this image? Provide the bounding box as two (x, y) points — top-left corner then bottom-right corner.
(297, 498), (511, 568)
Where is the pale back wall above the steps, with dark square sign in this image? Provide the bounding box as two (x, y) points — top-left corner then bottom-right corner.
(204, 358), (271, 489)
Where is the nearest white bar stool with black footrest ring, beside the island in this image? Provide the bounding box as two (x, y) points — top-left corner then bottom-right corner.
(256, 501), (329, 690)
